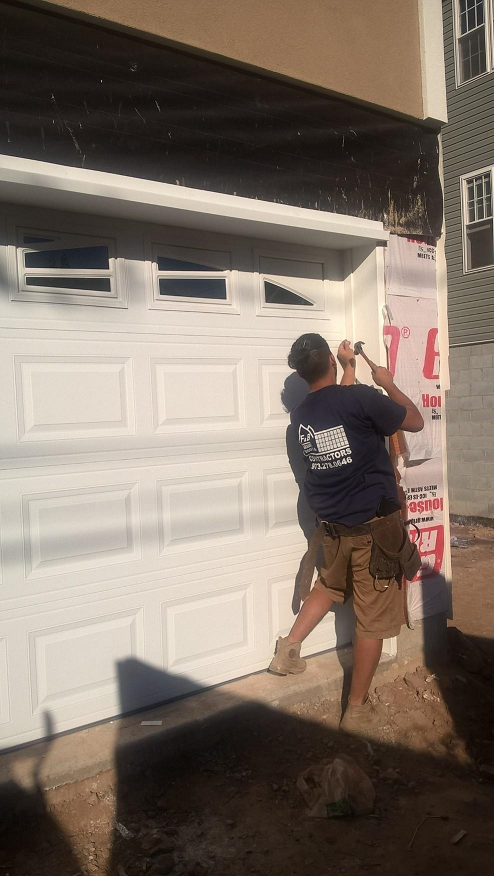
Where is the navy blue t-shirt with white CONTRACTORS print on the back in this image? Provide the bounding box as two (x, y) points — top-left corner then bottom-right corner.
(291, 385), (406, 526)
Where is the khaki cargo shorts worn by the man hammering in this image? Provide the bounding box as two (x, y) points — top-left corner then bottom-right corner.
(314, 520), (404, 639)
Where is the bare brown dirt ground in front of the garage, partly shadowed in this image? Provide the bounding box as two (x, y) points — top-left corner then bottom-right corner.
(0, 527), (494, 876)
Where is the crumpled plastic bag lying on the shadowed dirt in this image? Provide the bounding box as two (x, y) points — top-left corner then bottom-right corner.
(297, 754), (376, 818)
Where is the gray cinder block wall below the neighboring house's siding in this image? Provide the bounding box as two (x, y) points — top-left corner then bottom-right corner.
(446, 342), (494, 520)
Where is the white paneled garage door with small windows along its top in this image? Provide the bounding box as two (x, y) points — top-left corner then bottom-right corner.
(0, 208), (350, 745)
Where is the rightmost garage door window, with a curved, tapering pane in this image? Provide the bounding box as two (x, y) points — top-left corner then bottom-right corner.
(254, 251), (329, 319)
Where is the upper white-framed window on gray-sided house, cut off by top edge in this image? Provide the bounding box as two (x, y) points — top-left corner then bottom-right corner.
(453, 0), (494, 86)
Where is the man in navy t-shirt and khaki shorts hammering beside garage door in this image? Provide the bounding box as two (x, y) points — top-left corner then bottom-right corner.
(269, 333), (424, 731)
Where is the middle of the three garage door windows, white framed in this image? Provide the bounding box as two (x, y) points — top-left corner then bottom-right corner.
(150, 243), (239, 313)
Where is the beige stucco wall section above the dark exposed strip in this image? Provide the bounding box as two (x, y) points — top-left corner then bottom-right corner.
(37, 0), (423, 118)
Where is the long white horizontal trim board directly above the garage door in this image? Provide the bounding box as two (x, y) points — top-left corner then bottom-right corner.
(0, 155), (389, 249)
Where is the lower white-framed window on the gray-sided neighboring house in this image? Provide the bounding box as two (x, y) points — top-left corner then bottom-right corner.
(461, 167), (494, 273)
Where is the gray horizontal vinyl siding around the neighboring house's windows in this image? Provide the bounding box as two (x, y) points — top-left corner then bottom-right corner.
(442, 0), (494, 346)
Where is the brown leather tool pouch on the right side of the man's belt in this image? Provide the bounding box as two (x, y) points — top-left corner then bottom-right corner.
(369, 514), (422, 581)
